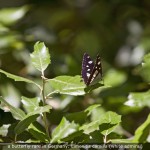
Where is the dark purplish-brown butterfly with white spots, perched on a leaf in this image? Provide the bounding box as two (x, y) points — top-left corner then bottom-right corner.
(81, 53), (102, 86)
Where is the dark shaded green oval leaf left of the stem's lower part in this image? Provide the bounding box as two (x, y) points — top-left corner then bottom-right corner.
(14, 114), (39, 134)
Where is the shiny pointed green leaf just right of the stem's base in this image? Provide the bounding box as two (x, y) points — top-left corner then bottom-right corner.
(51, 118), (79, 143)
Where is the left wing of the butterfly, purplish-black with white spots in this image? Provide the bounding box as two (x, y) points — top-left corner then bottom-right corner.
(81, 53), (94, 84)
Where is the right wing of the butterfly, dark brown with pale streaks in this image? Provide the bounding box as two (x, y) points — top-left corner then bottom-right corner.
(86, 54), (102, 85)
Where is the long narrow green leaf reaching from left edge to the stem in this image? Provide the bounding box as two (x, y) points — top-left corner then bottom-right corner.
(0, 69), (40, 88)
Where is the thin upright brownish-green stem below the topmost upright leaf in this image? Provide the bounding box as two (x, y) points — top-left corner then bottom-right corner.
(42, 76), (50, 139)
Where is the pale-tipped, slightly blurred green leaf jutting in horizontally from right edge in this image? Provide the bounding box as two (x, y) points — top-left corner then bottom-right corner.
(125, 90), (150, 108)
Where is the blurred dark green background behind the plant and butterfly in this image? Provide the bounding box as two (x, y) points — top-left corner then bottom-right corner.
(0, 0), (150, 138)
